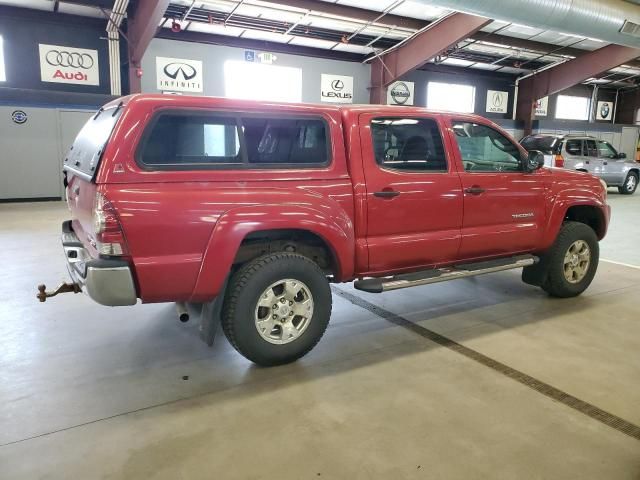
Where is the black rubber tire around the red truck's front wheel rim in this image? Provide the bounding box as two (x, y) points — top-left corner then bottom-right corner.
(542, 222), (600, 298)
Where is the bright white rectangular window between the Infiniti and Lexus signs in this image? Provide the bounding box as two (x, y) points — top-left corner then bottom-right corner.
(224, 60), (302, 102)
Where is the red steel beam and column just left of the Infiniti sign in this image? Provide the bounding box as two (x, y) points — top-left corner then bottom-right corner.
(127, 0), (170, 93)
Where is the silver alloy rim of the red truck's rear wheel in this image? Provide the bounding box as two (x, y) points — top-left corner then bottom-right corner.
(255, 278), (313, 345)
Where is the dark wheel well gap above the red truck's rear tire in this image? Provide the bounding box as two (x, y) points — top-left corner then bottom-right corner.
(233, 229), (339, 277)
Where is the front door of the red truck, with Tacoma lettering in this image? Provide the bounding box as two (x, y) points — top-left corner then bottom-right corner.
(450, 120), (549, 260)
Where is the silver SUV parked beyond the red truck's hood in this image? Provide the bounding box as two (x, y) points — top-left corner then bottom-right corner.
(520, 135), (640, 195)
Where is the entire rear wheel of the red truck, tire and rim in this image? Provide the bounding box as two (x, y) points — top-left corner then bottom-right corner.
(222, 252), (331, 366)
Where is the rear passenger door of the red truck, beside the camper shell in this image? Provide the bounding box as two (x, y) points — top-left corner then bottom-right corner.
(360, 114), (462, 273)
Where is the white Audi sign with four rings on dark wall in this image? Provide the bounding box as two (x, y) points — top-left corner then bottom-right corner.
(39, 43), (100, 85)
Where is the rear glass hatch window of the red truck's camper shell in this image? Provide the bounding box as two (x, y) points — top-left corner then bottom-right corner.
(64, 103), (122, 180)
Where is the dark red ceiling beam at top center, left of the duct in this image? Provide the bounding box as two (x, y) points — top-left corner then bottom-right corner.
(255, 0), (428, 30)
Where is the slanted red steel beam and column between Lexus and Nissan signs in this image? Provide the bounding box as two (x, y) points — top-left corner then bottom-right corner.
(370, 13), (491, 103)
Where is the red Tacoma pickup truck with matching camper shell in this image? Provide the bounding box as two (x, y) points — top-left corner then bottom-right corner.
(38, 95), (610, 365)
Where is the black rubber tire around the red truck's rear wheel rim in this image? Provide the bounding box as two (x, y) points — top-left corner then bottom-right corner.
(222, 252), (332, 366)
